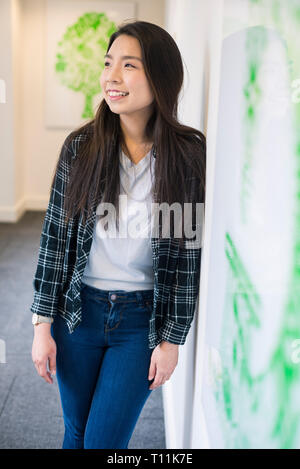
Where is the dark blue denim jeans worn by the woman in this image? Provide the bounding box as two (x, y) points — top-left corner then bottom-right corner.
(51, 284), (154, 449)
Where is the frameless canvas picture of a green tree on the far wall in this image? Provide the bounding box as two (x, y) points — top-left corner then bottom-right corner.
(45, 0), (136, 128)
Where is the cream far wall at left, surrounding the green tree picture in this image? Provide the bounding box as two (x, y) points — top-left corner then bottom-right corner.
(0, 0), (164, 222)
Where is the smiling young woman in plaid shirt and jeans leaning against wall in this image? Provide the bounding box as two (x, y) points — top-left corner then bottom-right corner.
(31, 21), (206, 449)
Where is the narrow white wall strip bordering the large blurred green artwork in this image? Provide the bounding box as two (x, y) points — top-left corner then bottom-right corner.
(188, 0), (223, 448)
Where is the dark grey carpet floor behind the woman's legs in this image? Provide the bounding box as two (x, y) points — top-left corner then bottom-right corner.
(0, 212), (165, 449)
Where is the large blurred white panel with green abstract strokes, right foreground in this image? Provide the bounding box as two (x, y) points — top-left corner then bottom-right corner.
(202, 0), (300, 449)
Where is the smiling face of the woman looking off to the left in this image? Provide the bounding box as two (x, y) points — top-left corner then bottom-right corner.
(100, 34), (154, 114)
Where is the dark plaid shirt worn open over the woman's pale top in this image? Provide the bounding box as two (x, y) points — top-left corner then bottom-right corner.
(30, 130), (202, 349)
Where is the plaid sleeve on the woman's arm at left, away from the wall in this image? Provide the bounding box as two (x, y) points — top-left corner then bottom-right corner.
(30, 137), (72, 317)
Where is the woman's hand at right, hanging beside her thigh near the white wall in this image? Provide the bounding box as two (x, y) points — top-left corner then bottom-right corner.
(148, 340), (179, 389)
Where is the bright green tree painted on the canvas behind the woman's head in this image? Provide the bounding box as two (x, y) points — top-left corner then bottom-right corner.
(55, 12), (117, 118)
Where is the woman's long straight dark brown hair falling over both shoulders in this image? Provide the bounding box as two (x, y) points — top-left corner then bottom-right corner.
(53, 21), (206, 239)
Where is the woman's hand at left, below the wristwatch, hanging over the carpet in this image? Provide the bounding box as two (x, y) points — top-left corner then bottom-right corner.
(32, 323), (56, 384)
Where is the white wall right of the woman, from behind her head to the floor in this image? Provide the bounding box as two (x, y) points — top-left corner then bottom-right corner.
(163, 0), (222, 449)
